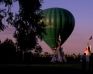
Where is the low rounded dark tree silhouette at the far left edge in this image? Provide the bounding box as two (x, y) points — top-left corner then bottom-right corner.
(0, 39), (16, 64)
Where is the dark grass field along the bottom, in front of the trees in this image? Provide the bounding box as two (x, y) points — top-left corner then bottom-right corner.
(0, 64), (91, 74)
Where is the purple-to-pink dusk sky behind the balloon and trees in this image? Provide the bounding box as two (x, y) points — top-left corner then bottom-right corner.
(0, 0), (93, 54)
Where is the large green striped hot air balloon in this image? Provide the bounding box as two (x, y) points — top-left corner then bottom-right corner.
(42, 8), (75, 48)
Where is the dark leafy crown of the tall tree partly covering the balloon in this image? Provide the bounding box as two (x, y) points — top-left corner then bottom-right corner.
(0, 0), (45, 51)
